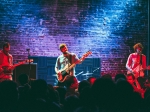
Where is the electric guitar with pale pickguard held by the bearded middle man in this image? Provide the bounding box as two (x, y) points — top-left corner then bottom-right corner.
(56, 51), (92, 82)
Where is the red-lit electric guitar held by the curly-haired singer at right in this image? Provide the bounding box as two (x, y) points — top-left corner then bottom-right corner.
(127, 65), (150, 78)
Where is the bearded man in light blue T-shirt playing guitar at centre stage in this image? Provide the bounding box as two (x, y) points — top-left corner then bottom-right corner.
(55, 44), (79, 86)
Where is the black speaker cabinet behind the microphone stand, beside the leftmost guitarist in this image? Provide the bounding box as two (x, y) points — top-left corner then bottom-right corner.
(13, 63), (37, 84)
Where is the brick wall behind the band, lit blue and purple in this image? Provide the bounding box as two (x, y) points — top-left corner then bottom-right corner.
(0, 0), (148, 75)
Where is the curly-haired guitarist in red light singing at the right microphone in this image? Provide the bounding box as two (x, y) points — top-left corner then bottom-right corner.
(126, 43), (146, 88)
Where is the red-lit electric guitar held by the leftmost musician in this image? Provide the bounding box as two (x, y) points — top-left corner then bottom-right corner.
(0, 59), (33, 75)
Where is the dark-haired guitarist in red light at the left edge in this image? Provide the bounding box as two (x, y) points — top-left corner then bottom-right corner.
(0, 42), (14, 82)
